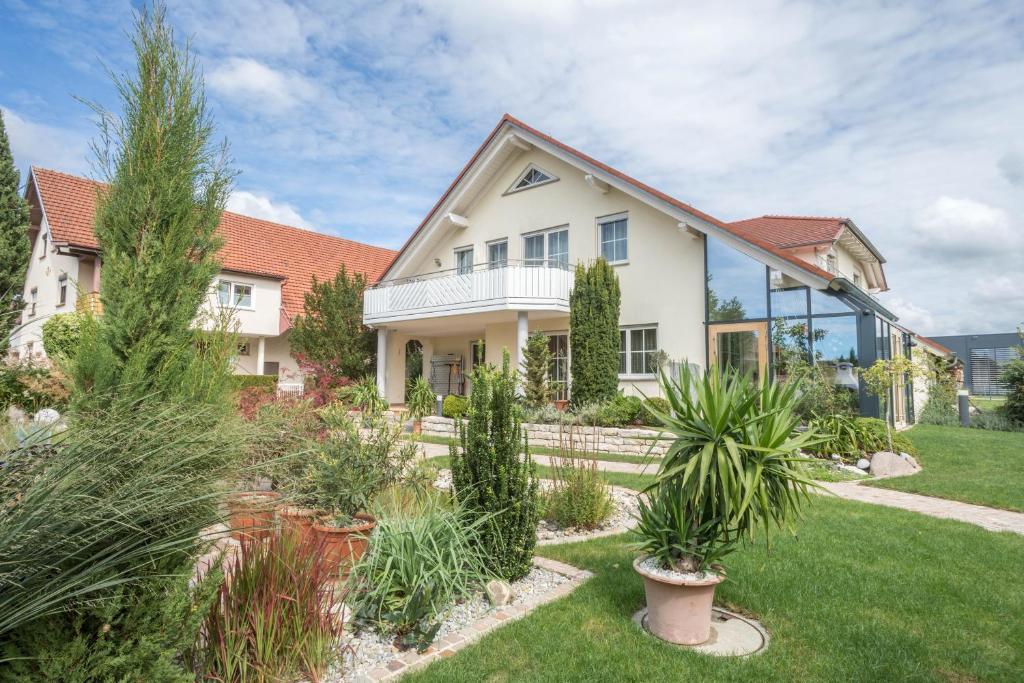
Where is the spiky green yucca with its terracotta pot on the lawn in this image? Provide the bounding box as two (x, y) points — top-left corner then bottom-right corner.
(633, 364), (816, 645)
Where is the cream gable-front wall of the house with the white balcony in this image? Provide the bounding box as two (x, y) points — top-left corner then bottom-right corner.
(388, 148), (706, 397)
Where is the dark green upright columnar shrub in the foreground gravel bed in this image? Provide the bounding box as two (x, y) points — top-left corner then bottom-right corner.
(451, 350), (538, 581)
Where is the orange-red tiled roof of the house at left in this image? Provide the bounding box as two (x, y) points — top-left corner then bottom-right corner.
(32, 167), (396, 329)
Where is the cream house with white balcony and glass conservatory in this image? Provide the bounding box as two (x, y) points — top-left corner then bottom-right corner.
(364, 115), (937, 424)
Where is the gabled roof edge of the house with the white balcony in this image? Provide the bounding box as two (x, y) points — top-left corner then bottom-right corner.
(382, 114), (835, 283)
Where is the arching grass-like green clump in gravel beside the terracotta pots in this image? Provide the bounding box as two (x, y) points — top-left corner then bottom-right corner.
(347, 498), (488, 651)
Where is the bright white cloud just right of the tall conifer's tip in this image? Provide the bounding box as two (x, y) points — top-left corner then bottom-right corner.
(206, 58), (316, 112)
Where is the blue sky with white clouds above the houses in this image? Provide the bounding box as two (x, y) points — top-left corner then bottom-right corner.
(0, 0), (1024, 335)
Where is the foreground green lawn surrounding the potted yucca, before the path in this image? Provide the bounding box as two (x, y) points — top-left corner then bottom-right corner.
(404, 497), (1024, 683)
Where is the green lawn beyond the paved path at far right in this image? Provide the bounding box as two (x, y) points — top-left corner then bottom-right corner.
(869, 425), (1024, 512)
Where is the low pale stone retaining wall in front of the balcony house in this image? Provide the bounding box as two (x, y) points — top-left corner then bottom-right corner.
(423, 417), (670, 457)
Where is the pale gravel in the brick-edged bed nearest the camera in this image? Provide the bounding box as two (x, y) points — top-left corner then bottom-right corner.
(323, 567), (570, 683)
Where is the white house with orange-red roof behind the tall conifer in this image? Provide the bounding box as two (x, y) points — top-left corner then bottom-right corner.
(10, 168), (395, 380)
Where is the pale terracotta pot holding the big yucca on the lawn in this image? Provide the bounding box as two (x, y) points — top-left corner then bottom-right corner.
(633, 557), (725, 645)
